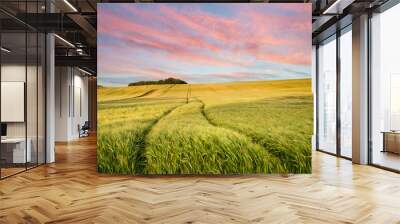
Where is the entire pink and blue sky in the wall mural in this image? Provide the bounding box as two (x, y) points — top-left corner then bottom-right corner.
(97, 3), (312, 86)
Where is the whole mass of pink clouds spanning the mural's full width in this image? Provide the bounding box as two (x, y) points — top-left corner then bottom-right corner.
(98, 4), (311, 67)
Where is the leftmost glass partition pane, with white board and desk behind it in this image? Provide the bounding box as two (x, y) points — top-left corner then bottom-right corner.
(1, 31), (27, 177)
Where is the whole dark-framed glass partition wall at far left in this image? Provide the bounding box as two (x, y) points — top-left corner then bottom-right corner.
(0, 0), (46, 178)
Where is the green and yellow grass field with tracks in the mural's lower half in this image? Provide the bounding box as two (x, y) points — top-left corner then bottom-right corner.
(97, 79), (313, 174)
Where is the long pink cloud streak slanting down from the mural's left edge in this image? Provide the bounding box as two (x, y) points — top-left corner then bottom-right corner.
(99, 8), (253, 66)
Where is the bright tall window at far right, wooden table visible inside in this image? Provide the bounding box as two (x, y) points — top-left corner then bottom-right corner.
(371, 6), (400, 170)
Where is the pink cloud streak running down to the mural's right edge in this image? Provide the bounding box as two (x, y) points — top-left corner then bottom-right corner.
(155, 7), (311, 64)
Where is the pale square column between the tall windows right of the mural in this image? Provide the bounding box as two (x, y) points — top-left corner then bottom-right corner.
(352, 15), (368, 164)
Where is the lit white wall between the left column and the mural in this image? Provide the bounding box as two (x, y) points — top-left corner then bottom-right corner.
(55, 67), (88, 141)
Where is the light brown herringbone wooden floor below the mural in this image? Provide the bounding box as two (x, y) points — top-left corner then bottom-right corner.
(0, 137), (400, 224)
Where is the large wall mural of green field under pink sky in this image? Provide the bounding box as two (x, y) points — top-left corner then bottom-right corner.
(97, 3), (313, 175)
